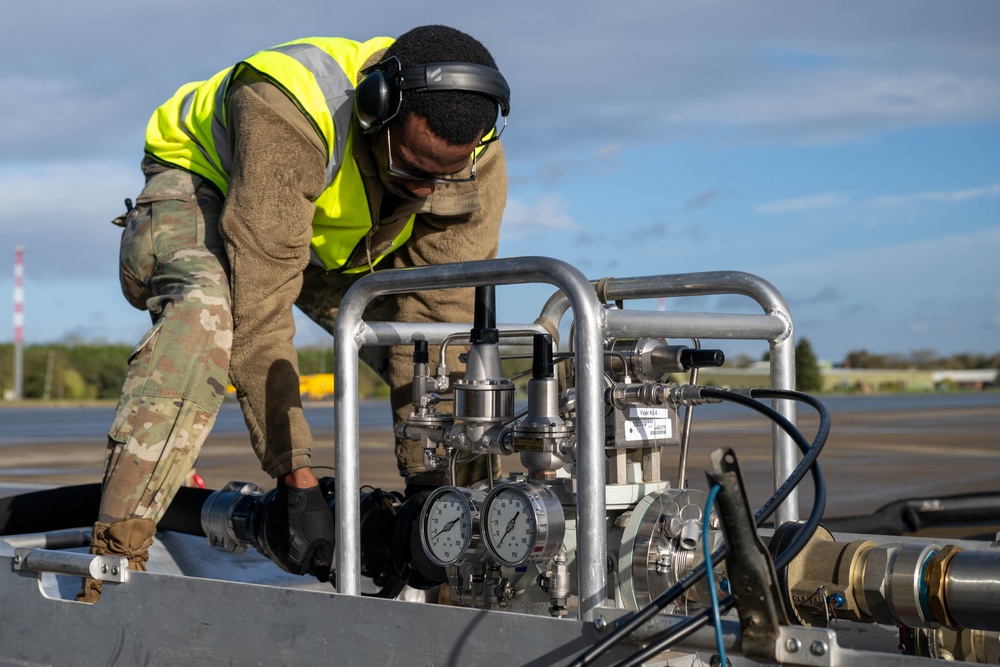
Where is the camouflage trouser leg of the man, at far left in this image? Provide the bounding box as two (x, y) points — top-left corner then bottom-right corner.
(100, 170), (233, 523)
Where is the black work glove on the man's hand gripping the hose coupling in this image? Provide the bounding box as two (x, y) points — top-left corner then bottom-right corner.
(266, 483), (336, 581)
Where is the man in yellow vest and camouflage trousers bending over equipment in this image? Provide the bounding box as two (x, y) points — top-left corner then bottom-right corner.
(78, 26), (509, 601)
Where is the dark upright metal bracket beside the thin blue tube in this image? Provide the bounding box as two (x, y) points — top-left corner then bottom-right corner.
(706, 449), (788, 662)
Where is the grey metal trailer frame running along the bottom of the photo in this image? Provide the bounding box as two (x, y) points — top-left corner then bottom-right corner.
(0, 529), (985, 667)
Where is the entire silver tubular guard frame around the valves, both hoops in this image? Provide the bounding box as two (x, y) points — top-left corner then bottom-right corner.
(334, 257), (798, 621)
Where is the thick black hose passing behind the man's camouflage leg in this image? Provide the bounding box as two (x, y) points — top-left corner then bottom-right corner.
(0, 484), (212, 536)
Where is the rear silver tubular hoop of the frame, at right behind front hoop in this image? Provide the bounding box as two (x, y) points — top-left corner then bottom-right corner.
(536, 271), (799, 525)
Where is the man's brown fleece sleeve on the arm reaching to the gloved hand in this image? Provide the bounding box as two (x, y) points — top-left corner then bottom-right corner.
(220, 77), (326, 477)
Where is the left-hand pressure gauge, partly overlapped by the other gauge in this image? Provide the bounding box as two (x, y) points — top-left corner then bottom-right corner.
(420, 486), (486, 567)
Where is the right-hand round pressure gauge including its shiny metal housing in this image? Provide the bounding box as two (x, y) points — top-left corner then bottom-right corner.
(482, 482), (566, 567)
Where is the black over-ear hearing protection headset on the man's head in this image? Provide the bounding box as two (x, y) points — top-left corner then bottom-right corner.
(354, 56), (510, 134)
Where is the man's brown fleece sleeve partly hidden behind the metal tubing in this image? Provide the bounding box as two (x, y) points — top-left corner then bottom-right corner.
(383, 141), (507, 475)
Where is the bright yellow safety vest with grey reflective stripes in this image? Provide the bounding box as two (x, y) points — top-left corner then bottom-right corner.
(146, 37), (414, 272)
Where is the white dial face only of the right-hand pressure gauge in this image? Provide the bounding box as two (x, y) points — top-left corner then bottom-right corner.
(483, 486), (538, 566)
